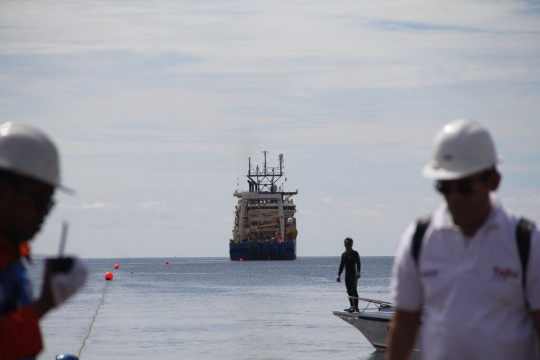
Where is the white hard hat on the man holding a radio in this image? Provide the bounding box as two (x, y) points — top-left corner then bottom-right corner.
(0, 122), (73, 192)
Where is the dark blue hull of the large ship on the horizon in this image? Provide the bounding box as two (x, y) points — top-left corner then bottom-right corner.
(229, 241), (296, 261)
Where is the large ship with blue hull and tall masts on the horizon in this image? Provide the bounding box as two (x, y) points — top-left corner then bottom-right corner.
(229, 151), (298, 261)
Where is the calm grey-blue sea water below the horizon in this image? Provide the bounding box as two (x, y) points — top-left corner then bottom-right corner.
(30, 256), (393, 360)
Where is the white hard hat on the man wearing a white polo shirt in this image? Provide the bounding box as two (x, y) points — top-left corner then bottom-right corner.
(422, 119), (498, 180)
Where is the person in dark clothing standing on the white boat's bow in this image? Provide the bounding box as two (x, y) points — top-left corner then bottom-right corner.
(336, 238), (362, 312)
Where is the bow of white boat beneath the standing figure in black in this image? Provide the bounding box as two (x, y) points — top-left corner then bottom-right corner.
(334, 298), (394, 351)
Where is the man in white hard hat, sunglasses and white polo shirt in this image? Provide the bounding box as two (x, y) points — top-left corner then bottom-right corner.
(386, 120), (540, 360)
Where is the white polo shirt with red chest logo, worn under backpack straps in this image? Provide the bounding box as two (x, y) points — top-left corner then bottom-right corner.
(391, 197), (540, 360)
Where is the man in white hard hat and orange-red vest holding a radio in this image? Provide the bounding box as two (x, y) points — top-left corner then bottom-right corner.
(0, 123), (87, 360)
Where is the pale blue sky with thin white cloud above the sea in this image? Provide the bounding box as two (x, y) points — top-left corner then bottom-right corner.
(0, 0), (540, 258)
